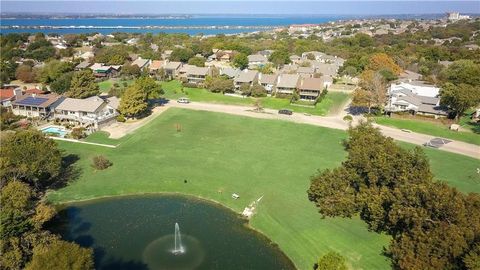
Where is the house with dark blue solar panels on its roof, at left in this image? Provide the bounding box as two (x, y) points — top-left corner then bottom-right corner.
(12, 94), (64, 118)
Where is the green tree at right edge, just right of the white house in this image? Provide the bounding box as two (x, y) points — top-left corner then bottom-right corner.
(440, 83), (480, 119)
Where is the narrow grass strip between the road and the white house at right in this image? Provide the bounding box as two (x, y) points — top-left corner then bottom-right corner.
(374, 116), (480, 145)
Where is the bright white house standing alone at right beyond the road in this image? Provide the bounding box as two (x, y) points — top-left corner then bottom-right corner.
(385, 82), (448, 118)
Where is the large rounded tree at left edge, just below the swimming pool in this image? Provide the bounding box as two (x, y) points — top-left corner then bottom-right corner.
(0, 130), (62, 188)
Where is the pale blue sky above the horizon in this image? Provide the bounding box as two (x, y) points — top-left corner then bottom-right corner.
(1, 0), (480, 15)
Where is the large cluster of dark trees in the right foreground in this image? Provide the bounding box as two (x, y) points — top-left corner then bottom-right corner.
(308, 123), (480, 269)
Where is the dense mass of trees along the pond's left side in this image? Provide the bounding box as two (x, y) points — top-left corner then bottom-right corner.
(0, 129), (93, 270)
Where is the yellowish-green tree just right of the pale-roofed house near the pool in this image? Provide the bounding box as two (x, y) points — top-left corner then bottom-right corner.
(118, 84), (148, 117)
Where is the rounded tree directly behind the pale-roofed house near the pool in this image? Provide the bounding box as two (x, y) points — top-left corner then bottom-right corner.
(67, 69), (100, 98)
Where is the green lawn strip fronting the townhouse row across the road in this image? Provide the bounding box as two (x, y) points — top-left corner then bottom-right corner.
(162, 81), (349, 115)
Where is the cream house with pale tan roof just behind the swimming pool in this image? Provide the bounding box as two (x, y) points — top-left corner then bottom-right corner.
(53, 96), (118, 130)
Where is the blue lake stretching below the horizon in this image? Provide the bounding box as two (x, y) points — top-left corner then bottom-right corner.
(1, 16), (339, 35)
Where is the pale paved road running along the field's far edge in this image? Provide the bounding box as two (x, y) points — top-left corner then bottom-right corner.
(165, 102), (480, 159)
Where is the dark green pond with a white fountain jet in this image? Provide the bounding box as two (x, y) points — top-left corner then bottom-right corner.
(51, 195), (295, 270)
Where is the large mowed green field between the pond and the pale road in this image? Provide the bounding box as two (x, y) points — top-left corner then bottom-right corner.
(49, 108), (480, 269)
